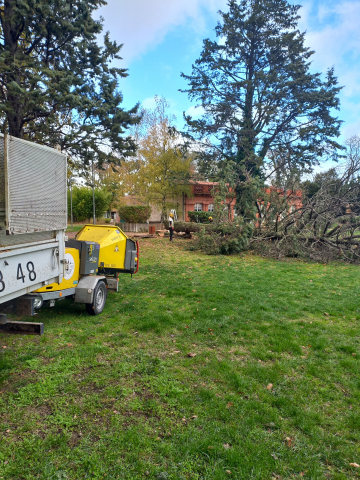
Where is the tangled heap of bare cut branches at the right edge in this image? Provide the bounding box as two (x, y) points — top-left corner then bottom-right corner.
(250, 142), (360, 263)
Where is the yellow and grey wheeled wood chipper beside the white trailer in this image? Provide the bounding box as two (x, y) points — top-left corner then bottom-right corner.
(31, 225), (139, 315)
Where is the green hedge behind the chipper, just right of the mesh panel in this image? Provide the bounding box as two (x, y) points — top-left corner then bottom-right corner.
(68, 187), (111, 222)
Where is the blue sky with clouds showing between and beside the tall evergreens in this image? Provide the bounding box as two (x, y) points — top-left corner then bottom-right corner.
(99, 0), (360, 141)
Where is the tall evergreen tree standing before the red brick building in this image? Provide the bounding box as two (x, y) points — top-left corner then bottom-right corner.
(182, 0), (341, 212)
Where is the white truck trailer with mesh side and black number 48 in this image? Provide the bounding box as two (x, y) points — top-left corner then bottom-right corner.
(0, 135), (67, 334)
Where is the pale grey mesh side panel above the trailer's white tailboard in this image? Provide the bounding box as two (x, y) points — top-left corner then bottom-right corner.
(5, 136), (67, 234)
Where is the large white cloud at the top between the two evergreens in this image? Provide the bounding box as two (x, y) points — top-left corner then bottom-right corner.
(95, 0), (226, 64)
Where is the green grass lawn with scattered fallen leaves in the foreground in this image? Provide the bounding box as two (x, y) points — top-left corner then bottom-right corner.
(0, 239), (360, 480)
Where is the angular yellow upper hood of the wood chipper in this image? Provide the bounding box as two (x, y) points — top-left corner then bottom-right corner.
(76, 225), (128, 270)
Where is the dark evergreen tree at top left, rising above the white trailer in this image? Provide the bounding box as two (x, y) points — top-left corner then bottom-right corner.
(0, 0), (138, 164)
